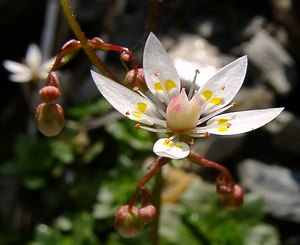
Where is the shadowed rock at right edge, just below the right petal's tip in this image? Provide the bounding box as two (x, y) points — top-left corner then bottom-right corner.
(265, 110), (300, 156)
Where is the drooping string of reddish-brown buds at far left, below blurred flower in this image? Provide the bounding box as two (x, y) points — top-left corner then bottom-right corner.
(35, 72), (65, 137)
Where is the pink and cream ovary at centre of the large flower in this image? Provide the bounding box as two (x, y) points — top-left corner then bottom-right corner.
(166, 89), (201, 132)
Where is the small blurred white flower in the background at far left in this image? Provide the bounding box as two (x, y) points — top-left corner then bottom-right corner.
(3, 44), (55, 83)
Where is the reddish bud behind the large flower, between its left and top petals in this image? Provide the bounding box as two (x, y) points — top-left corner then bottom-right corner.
(124, 68), (148, 92)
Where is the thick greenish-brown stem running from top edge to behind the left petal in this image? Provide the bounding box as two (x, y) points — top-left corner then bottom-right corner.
(60, 0), (118, 81)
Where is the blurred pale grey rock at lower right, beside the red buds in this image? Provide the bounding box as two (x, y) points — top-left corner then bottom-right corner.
(238, 159), (300, 222)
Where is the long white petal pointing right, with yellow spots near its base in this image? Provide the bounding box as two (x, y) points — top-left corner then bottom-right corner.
(202, 107), (284, 135)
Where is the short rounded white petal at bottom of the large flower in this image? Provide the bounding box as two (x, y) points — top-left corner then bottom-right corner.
(153, 138), (190, 159)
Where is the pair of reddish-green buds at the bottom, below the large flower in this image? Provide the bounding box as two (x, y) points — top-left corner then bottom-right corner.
(114, 204), (157, 238)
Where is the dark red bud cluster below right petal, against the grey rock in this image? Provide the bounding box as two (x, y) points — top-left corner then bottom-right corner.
(216, 172), (244, 209)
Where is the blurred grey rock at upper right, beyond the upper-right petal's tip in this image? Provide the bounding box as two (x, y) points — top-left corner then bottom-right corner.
(245, 30), (295, 95)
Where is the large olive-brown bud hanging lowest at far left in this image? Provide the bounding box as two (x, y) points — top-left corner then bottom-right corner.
(35, 103), (65, 137)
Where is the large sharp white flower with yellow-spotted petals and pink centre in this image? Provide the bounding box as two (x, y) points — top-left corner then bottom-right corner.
(92, 33), (284, 159)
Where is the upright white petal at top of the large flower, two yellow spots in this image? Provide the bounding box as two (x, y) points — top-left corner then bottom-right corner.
(143, 33), (180, 104)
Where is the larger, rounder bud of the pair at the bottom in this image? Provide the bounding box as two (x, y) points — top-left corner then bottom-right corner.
(114, 205), (144, 238)
